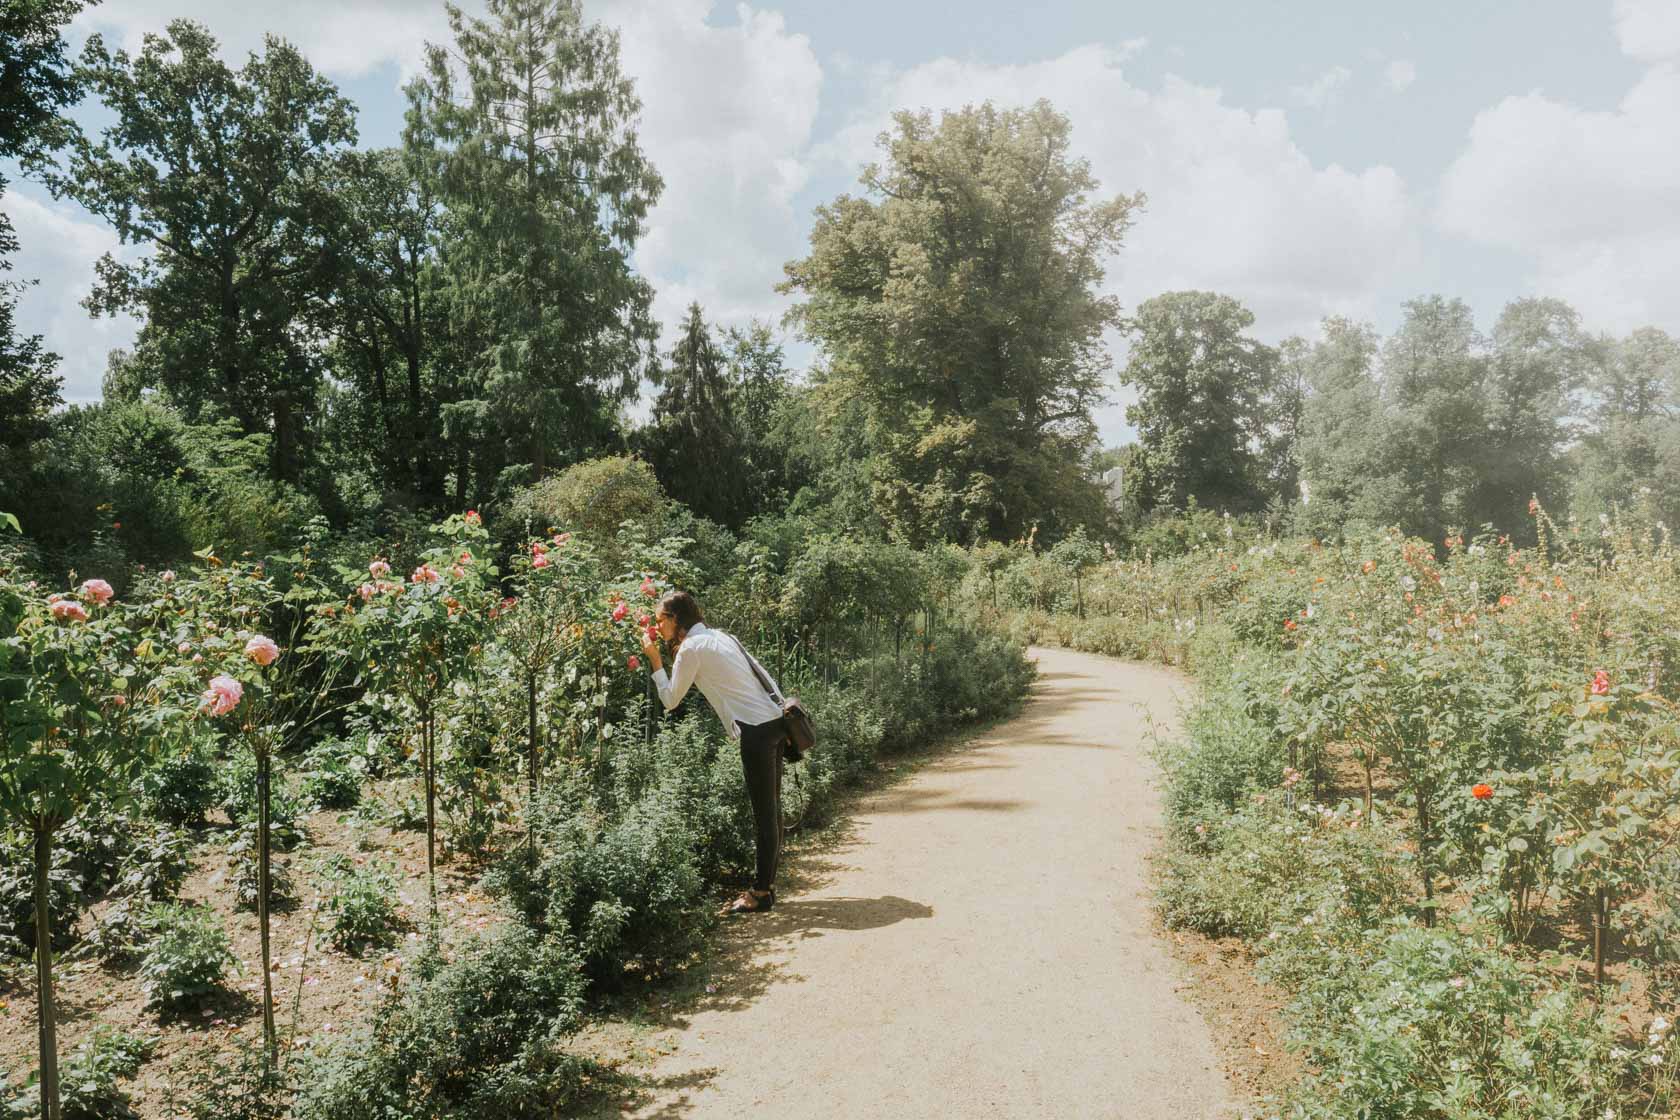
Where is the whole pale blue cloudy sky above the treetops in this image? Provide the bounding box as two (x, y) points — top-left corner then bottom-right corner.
(0, 0), (1680, 447)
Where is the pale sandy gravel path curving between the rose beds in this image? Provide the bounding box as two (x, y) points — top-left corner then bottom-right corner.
(630, 650), (1242, 1120)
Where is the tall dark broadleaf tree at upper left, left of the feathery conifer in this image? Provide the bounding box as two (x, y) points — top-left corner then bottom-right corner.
(45, 20), (356, 482)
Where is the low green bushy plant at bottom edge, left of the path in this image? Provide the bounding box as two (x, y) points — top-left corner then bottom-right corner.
(292, 925), (585, 1120)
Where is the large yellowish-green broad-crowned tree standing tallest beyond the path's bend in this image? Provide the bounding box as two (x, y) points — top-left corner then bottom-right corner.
(783, 101), (1142, 541)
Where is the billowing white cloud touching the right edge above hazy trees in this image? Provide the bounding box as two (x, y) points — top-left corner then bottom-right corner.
(1436, 47), (1680, 331)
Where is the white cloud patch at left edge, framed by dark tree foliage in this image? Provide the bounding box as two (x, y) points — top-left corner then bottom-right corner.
(0, 183), (139, 401)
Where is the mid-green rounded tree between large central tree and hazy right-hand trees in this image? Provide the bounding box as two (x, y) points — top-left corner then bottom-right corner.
(1121, 292), (1277, 512)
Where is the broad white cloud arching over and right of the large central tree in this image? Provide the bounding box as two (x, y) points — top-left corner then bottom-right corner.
(820, 47), (1416, 345)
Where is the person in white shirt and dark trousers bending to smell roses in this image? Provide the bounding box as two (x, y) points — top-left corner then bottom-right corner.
(642, 591), (788, 913)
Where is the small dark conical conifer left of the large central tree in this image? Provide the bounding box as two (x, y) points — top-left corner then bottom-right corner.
(648, 304), (751, 526)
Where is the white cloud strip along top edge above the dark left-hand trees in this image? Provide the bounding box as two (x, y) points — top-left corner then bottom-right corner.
(74, 0), (460, 79)
